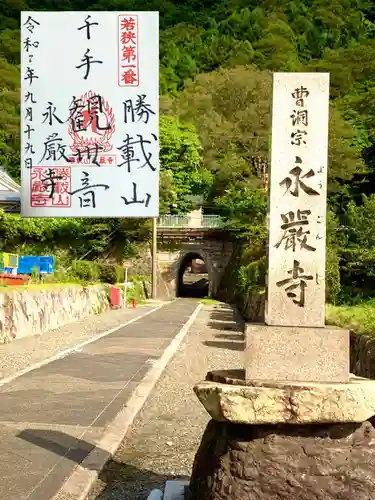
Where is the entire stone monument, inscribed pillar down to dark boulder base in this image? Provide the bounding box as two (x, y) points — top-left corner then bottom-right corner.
(189, 73), (375, 500)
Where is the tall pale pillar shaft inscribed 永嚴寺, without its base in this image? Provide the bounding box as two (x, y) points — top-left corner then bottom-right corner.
(266, 73), (328, 326)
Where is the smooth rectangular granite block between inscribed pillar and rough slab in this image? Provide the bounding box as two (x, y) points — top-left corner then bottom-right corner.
(245, 323), (350, 382)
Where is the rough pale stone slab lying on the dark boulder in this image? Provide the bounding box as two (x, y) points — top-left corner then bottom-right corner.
(194, 377), (375, 424)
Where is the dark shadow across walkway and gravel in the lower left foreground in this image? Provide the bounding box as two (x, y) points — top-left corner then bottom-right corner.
(18, 429), (188, 500)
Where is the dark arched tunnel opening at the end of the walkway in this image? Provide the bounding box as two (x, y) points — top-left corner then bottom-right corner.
(176, 253), (209, 298)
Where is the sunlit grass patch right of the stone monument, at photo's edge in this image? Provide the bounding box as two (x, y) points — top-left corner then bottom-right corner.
(326, 299), (375, 337)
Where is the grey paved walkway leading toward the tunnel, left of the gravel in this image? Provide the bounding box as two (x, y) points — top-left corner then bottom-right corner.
(0, 300), (197, 500)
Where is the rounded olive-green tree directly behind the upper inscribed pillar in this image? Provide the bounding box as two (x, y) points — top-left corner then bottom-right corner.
(170, 67), (365, 205)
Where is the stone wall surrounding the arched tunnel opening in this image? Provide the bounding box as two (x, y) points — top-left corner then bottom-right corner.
(158, 240), (233, 295)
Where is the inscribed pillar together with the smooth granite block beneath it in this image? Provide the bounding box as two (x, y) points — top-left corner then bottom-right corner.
(245, 73), (349, 382)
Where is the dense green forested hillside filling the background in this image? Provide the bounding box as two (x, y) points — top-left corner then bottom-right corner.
(0, 0), (375, 301)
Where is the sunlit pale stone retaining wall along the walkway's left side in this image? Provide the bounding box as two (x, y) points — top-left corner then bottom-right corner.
(0, 286), (109, 344)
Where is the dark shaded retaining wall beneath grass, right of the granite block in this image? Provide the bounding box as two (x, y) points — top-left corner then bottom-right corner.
(350, 332), (375, 379)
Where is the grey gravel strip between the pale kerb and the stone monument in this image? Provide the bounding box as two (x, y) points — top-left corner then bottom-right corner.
(87, 304), (244, 500)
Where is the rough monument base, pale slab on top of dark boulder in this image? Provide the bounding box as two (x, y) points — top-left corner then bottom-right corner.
(190, 370), (375, 500)
